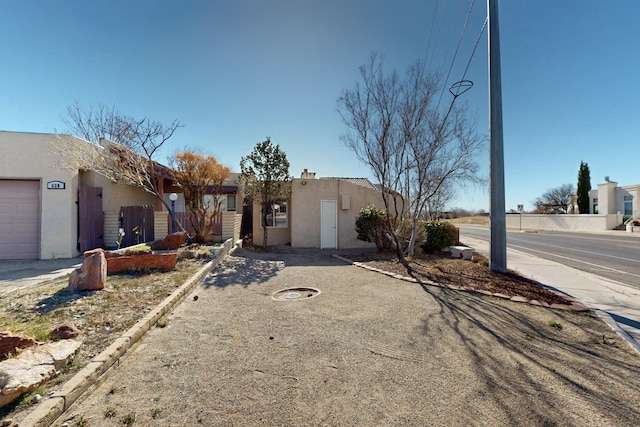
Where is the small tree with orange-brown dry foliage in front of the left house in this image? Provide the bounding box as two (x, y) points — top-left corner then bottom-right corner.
(169, 149), (231, 242)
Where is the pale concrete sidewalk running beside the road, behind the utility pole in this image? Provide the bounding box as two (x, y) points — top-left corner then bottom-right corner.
(461, 236), (640, 354)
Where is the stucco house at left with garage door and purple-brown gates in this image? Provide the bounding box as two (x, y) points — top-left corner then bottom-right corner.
(0, 131), (241, 259)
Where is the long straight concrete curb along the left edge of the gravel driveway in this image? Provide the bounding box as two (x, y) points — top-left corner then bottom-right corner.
(19, 239), (236, 427)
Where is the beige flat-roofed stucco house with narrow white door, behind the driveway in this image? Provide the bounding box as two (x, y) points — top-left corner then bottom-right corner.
(253, 169), (384, 249)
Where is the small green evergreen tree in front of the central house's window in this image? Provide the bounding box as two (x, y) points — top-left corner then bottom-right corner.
(240, 137), (291, 248)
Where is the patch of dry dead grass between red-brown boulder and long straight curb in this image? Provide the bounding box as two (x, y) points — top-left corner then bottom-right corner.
(0, 254), (208, 418)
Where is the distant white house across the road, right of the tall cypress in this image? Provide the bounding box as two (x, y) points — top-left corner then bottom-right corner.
(589, 176), (640, 220)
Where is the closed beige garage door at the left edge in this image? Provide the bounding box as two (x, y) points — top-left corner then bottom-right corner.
(0, 179), (40, 259)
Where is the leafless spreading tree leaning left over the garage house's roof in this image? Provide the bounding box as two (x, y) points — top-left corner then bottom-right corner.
(53, 102), (181, 214)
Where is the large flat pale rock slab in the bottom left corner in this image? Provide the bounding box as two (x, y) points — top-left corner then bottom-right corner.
(0, 340), (82, 407)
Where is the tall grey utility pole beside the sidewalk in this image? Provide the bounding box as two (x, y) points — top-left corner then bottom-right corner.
(487, 0), (507, 272)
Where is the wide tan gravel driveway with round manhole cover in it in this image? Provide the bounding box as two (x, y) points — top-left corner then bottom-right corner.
(56, 249), (640, 426)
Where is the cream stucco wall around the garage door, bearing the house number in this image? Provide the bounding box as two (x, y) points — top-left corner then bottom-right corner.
(0, 132), (83, 259)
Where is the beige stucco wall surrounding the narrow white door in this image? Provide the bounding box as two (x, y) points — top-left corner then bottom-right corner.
(290, 179), (384, 249)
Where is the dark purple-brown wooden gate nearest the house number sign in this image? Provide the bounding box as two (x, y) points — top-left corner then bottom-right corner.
(76, 186), (104, 252)
